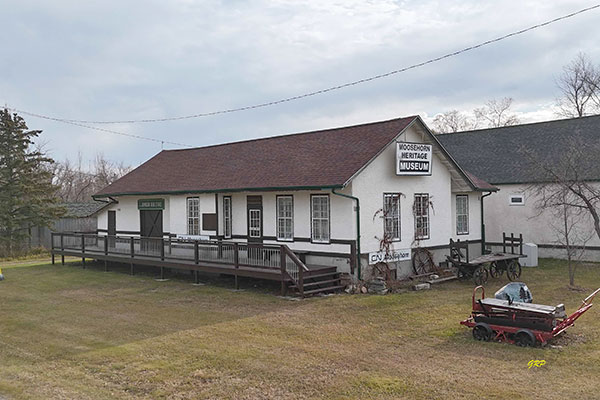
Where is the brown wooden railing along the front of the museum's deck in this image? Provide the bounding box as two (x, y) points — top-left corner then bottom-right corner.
(51, 232), (308, 290)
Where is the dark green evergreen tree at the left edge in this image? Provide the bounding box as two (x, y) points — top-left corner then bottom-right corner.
(0, 109), (64, 256)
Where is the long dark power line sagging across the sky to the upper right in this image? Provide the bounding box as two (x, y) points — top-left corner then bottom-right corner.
(7, 4), (600, 125)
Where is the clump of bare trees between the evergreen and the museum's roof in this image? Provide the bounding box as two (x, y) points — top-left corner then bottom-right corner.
(52, 154), (131, 203)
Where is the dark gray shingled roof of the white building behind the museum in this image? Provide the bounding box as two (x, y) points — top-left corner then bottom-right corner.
(436, 115), (600, 185)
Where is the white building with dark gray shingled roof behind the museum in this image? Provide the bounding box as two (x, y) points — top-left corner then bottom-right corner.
(437, 116), (600, 261)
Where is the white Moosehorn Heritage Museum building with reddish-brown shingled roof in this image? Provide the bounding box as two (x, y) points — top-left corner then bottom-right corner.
(83, 116), (496, 290)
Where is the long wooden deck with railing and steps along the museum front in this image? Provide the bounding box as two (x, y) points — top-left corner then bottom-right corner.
(51, 233), (342, 297)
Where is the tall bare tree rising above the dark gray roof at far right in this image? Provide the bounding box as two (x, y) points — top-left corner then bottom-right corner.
(556, 53), (600, 117)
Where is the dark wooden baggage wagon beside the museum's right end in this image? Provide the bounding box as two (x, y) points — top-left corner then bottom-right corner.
(446, 233), (525, 285)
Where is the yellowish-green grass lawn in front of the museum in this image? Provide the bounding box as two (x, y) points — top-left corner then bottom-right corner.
(0, 260), (600, 399)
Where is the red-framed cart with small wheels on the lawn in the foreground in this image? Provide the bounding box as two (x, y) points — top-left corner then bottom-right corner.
(460, 285), (600, 347)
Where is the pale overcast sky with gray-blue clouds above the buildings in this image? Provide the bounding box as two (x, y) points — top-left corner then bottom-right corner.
(0, 0), (600, 166)
